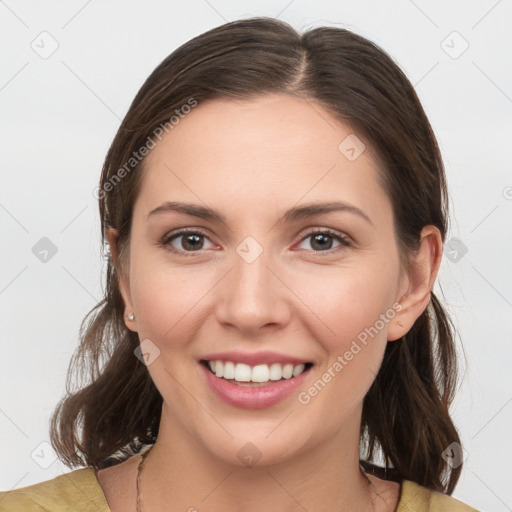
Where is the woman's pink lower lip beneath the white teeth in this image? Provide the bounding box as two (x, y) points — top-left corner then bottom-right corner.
(199, 363), (311, 409)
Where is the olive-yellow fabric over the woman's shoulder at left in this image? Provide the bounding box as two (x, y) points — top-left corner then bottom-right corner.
(0, 468), (110, 512)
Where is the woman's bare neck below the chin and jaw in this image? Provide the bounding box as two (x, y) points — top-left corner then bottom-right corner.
(141, 406), (373, 512)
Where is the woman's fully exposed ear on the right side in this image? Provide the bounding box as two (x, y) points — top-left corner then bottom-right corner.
(388, 226), (443, 341)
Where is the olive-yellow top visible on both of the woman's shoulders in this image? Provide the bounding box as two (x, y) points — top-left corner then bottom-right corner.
(0, 468), (478, 512)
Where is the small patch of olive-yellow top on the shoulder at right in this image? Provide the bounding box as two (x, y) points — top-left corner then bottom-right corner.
(396, 480), (478, 512)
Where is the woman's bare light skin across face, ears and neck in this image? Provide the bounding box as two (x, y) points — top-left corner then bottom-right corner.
(98, 94), (442, 512)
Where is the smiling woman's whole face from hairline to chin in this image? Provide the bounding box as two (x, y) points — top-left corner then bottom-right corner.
(117, 95), (407, 464)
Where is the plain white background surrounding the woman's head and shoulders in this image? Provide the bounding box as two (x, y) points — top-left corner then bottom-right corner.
(0, 0), (512, 512)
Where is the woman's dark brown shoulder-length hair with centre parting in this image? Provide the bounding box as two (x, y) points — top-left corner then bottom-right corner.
(50, 17), (462, 494)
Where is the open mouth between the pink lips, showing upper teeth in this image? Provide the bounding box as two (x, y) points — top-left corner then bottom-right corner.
(200, 359), (313, 387)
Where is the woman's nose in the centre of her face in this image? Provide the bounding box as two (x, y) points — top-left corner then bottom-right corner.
(216, 245), (293, 337)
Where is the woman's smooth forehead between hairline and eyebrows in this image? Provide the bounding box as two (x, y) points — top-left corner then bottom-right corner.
(137, 94), (389, 228)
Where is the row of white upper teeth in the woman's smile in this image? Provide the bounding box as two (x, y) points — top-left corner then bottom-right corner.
(208, 361), (306, 382)
